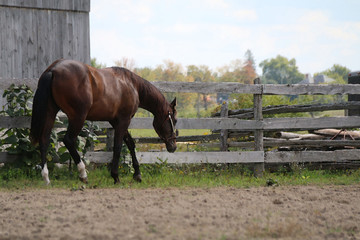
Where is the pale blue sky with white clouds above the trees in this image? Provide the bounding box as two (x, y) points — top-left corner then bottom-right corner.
(90, 0), (360, 75)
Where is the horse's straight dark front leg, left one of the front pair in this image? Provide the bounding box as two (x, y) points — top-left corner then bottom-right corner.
(110, 120), (130, 184)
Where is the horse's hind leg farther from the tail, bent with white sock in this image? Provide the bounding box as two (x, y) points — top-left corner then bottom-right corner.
(64, 117), (87, 183)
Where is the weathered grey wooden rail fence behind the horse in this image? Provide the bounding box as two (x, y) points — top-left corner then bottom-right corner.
(0, 79), (360, 172)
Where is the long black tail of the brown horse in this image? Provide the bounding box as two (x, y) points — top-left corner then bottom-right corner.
(30, 71), (53, 144)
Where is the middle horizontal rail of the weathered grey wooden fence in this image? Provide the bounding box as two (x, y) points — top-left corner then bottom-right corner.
(0, 116), (360, 132)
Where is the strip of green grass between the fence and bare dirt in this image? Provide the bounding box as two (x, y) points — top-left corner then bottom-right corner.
(0, 163), (360, 190)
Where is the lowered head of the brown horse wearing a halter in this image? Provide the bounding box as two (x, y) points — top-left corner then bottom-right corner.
(153, 98), (178, 152)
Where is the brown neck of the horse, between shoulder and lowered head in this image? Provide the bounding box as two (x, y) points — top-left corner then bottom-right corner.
(138, 79), (166, 116)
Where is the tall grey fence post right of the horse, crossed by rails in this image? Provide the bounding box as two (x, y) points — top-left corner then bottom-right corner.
(254, 78), (265, 177)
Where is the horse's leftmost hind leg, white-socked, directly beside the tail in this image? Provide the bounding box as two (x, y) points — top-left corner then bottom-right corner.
(39, 104), (59, 185)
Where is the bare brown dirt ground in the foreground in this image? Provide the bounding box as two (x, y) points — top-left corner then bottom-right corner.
(0, 184), (360, 239)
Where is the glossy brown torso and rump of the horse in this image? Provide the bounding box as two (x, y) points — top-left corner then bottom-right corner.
(44, 60), (139, 121)
